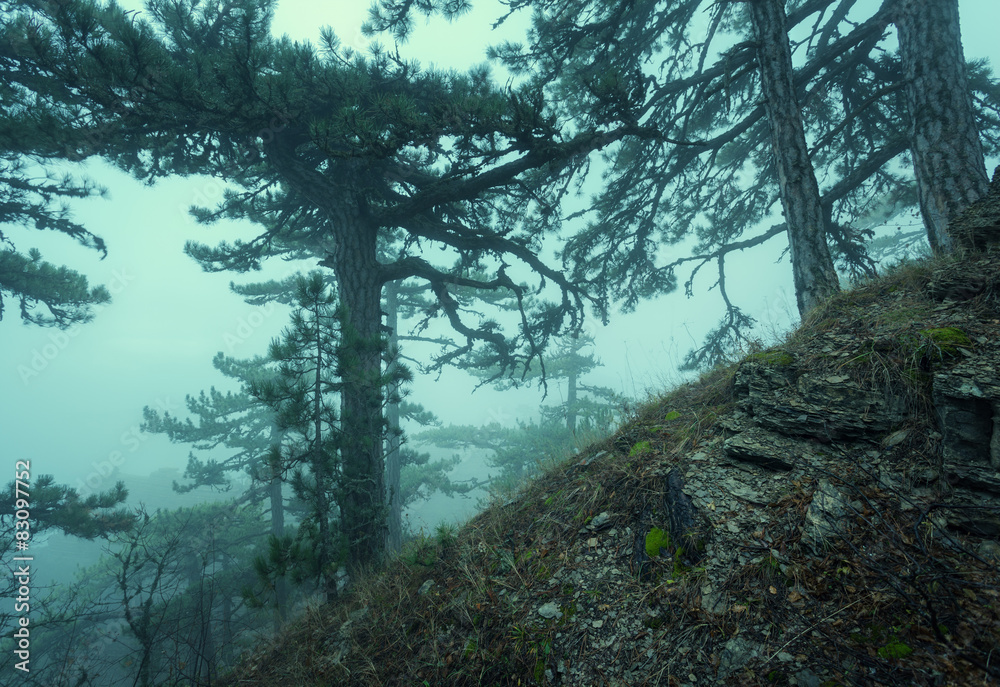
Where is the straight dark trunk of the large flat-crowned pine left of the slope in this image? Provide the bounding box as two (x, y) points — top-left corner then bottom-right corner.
(332, 215), (386, 568)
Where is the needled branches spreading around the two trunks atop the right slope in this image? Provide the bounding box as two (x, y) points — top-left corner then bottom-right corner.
(370, 0), (1000, 365)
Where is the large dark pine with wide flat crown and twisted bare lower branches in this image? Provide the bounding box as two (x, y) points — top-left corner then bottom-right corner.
(0, 0), (640, 564)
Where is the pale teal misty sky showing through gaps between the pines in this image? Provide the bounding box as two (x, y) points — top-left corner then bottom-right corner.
(0, 0), (1000, 516)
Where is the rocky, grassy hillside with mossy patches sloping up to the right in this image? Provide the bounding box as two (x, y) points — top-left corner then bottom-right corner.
(219, 253), (1000, 687)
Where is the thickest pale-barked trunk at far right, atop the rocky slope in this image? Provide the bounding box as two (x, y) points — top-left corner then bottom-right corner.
(893, 0), (989, 253)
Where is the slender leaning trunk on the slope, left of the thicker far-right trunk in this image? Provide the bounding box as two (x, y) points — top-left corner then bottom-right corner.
(750, 0), (840, 315)
